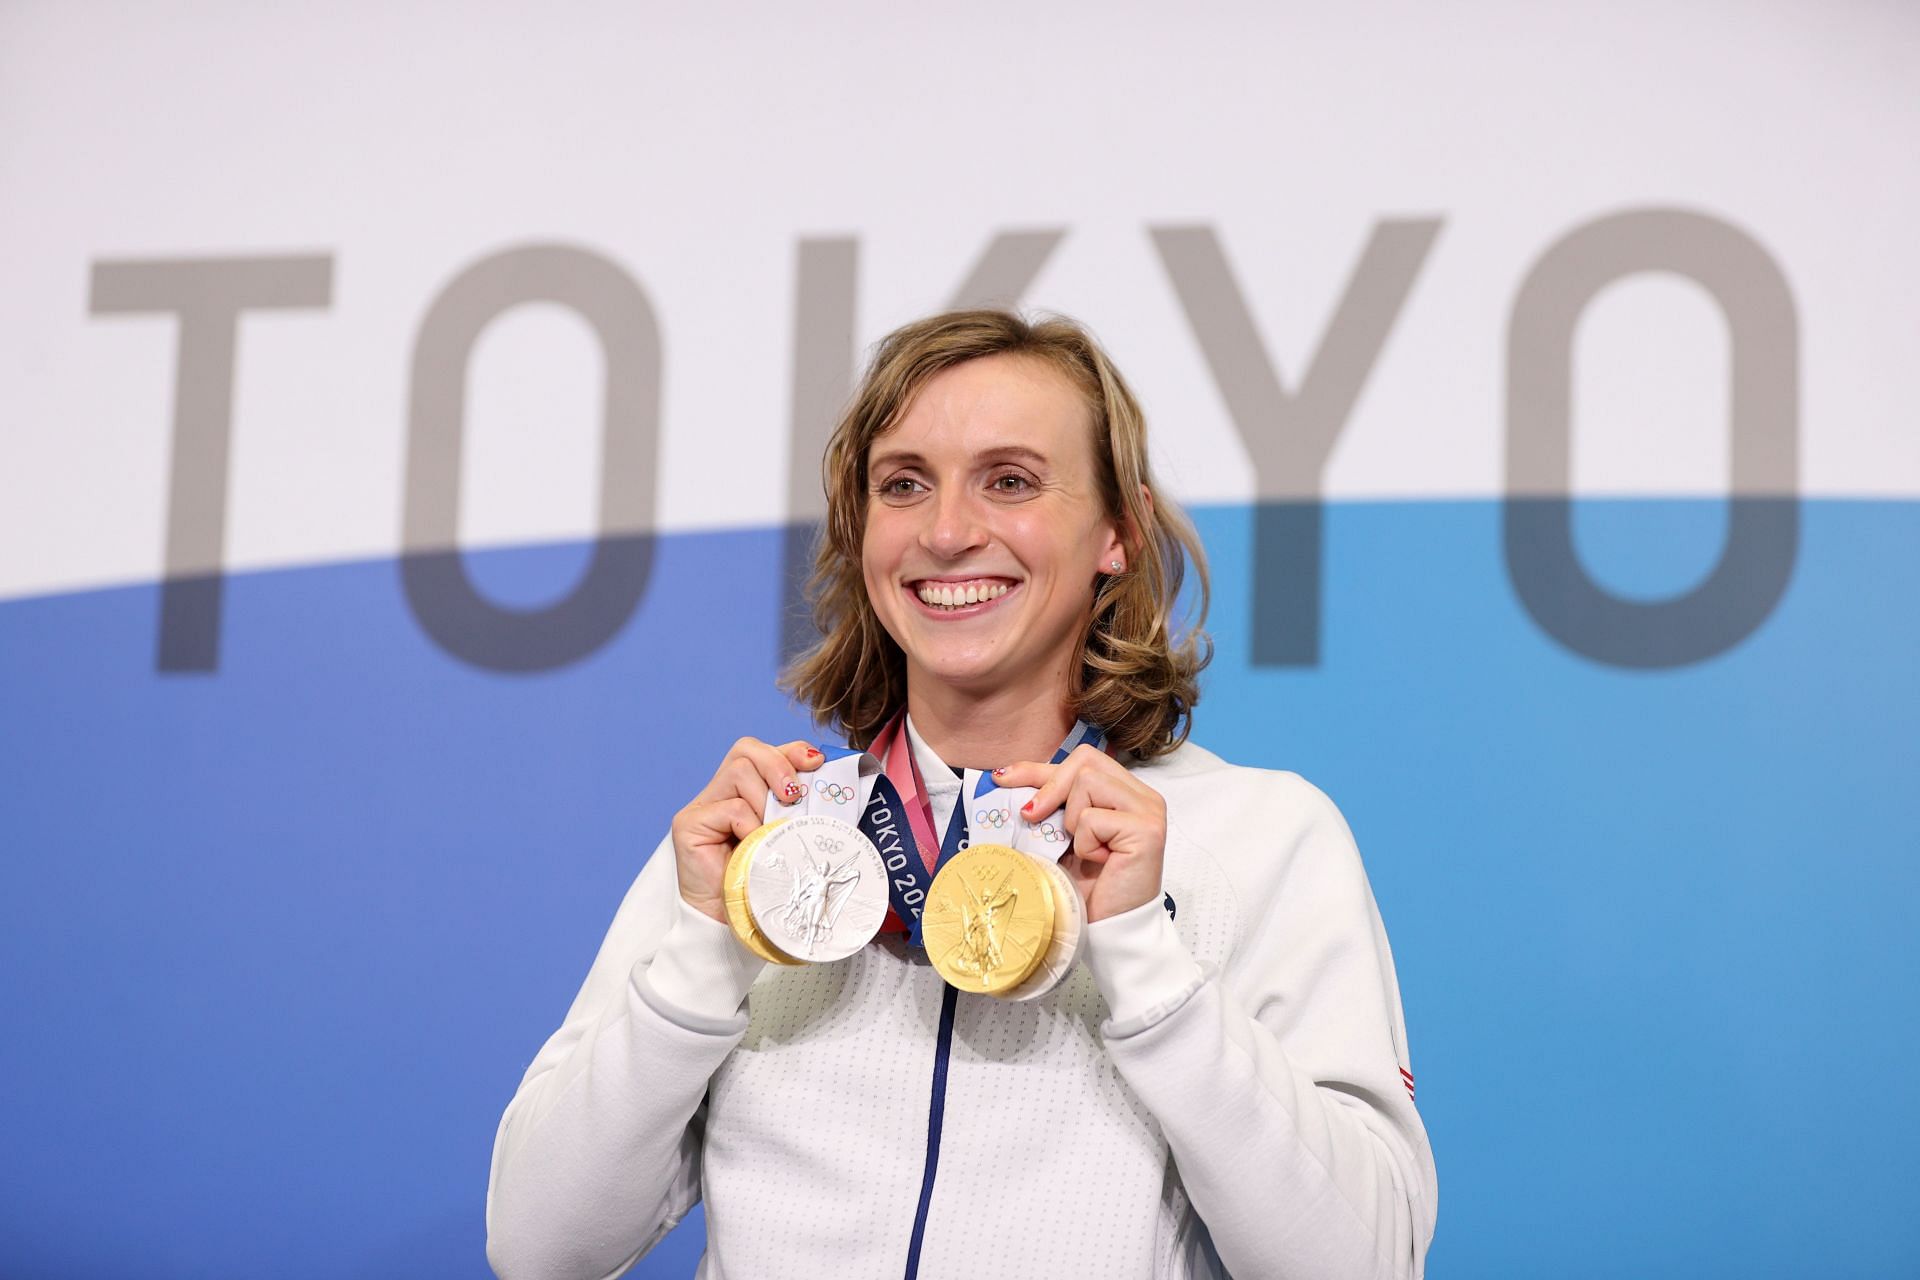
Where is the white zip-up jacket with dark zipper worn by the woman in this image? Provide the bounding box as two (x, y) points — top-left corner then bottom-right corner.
(486, 745), (1436, 1280)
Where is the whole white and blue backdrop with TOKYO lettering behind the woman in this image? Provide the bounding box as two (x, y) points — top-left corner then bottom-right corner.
(0, 0), (1920, 1278)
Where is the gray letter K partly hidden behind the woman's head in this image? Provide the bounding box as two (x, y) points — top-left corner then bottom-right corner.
(780, 230), (1066, 662)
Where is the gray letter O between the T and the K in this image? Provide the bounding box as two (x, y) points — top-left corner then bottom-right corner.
(401, 246), (660, 672)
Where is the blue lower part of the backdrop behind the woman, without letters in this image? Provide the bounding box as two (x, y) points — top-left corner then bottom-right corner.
(0, 501), (1920, 1278)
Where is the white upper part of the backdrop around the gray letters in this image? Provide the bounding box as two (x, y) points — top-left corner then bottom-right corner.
(0, 4), (1920, 595)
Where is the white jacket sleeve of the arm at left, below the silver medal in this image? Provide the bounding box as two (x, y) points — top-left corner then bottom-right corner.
(486, 841), (764, 1280)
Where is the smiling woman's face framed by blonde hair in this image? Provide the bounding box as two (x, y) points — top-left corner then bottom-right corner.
(860, 355), (1127, 697)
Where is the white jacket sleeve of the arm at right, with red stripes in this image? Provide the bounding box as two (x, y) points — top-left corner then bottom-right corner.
(1087, 773), (1438, 1280)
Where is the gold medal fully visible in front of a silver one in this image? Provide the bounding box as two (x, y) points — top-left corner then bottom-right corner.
(920, 844), (1054, 996)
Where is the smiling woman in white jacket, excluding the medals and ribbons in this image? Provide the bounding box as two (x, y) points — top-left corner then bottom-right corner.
(488, 311), (1434, 1280)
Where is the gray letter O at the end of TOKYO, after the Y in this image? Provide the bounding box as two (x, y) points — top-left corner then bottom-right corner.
(1503, 209), (1799, 668)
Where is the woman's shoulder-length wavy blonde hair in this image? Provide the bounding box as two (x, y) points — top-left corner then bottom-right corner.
(780, 311), (1213, 760)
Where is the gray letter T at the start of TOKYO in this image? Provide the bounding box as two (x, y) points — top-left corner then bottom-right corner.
(90, 255), (334, 672)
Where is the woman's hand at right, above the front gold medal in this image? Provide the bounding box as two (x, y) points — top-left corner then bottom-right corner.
(993, 745), (1167, 921)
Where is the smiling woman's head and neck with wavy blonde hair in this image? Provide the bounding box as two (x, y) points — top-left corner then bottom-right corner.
(789, 311), (1208, 771)
